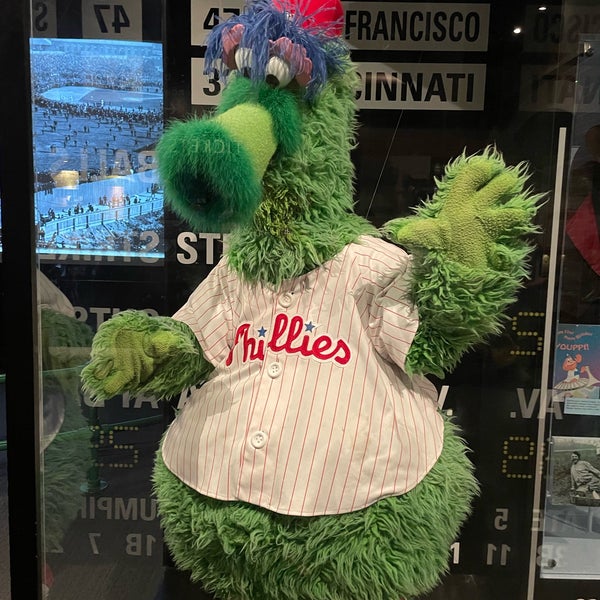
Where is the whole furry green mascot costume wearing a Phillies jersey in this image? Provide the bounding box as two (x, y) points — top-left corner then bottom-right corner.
(82, 0), (539, 600)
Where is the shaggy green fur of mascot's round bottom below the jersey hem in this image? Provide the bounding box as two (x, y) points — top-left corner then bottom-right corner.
(153, 421), (478, 600)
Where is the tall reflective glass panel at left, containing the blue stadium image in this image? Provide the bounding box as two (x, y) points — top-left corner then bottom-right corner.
(30, 1), (166, 600)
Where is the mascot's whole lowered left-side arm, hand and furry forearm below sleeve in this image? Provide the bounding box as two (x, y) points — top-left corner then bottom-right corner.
(81, 310), (212, 400)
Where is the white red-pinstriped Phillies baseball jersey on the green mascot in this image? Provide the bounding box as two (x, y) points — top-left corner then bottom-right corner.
(162, 236), (443, 516)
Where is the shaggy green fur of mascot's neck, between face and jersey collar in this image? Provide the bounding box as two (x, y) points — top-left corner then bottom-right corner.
(226, 63), (379, 285)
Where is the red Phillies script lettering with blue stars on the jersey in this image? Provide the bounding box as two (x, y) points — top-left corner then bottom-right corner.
(225, 313), (350, 366)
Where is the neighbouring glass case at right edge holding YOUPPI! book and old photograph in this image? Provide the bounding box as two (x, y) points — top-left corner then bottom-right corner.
(541, 34), (600, 580)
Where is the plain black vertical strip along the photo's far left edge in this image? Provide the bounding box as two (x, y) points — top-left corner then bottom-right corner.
(0, 0), (40, 600)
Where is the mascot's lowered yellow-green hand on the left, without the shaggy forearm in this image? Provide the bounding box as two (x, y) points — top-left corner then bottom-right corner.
(81, 311), (178, 400)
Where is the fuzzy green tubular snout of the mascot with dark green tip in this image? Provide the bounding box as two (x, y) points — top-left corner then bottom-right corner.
(156, 77), (301, 232)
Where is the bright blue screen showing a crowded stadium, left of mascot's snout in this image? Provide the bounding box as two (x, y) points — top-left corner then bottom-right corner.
(30, 38), (164, 264)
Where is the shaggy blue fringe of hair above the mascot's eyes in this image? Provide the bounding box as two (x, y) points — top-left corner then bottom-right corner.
(204, 0), (349, 101)
